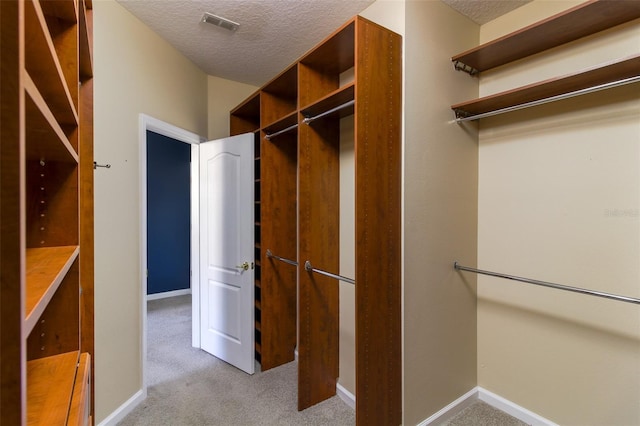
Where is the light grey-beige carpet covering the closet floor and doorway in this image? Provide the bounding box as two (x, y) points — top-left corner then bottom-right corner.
(119, 296), (525, 426)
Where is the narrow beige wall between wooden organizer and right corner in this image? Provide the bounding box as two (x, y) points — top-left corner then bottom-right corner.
(403, 0), (479, 425)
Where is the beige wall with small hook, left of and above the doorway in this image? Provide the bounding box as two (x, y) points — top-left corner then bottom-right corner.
(93, 1), (207, 423)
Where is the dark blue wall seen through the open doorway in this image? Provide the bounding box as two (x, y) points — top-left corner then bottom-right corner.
(147, 131), (191, 294)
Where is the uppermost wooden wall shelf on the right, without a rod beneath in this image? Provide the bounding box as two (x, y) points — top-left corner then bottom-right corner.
(451, 0), (640, 74)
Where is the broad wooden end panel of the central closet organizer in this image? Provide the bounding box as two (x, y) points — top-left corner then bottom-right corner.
(355, 18), (402, 425)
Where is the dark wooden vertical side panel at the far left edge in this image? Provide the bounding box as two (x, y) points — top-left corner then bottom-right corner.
(0, 1), (26, 425)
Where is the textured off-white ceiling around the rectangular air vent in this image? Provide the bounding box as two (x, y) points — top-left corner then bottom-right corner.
(119, 0), (529, 86)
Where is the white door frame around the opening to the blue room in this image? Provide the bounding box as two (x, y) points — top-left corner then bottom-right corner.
(138, 114), (206, 397)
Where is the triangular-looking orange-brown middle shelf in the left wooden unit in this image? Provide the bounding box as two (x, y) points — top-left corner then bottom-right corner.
(25, 246), (80, 335)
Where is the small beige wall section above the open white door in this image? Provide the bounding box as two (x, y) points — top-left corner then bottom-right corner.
(207, 75), (259, 139)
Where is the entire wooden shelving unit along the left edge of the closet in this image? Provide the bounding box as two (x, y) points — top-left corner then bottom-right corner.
(0, 0), (93, 425)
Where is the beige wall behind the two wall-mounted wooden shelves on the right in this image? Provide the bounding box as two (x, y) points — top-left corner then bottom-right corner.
(478, 1), (640, 425)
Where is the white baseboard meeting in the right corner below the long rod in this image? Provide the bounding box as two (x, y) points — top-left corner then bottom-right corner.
(417, 386), (558, 426)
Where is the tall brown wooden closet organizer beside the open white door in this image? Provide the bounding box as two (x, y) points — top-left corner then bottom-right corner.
(230, 17), (402, 424)
